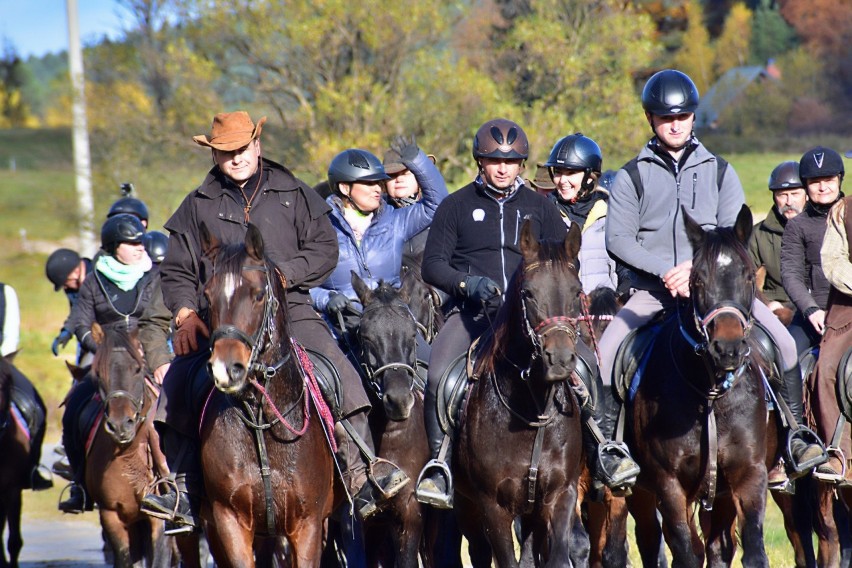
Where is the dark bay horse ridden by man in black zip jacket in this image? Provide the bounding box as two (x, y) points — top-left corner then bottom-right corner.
(452, 221), (583, 568)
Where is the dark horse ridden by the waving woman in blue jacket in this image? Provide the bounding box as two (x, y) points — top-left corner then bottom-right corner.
(352, 272), (432, 568)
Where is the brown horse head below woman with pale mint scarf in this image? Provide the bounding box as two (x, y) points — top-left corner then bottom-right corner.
(92, 324), (147, 449)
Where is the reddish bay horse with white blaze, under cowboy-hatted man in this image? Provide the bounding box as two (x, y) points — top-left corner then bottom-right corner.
(200, 224), (335, 568)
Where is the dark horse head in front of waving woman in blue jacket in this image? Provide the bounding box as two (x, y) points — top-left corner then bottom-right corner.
(352, 272), (417, 421)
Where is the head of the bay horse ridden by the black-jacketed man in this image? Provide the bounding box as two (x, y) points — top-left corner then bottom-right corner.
(507, 221), (583, 382)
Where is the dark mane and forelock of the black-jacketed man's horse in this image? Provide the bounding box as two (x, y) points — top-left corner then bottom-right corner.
(477, 240), (577, 373)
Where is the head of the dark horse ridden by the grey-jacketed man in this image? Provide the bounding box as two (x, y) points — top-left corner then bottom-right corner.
(683, 205), (755, 375)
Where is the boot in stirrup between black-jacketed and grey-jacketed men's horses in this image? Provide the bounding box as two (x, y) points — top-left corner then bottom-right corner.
(583, 386), (639, 494)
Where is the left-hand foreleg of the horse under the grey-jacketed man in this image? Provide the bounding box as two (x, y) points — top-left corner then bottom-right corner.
(656, 478), (704, 568)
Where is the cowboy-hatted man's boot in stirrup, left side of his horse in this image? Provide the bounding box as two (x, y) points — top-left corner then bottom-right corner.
(140, 425), (202, 534)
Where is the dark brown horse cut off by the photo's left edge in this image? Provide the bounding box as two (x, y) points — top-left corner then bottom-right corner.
(0, 358), (30, 567)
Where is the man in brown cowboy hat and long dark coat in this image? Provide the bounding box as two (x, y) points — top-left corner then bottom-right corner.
(142, 111), (408, 532)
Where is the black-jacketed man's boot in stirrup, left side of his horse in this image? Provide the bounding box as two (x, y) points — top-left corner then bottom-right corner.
(415, 389), (453, 509)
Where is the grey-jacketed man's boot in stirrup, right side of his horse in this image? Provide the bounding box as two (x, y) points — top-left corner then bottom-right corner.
(780, 364), (828, 479)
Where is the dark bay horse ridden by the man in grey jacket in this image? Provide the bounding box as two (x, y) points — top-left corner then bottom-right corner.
(626, 206), (768, 566)
